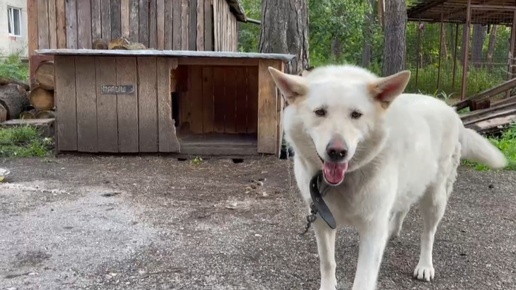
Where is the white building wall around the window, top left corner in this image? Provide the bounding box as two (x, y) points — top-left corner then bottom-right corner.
(0, 0), (28, 57)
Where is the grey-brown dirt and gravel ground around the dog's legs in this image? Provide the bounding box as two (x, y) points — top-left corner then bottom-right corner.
(0, 157), (516, 290)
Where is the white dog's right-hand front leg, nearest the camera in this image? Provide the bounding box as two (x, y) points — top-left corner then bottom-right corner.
(353, 219), (389, 290)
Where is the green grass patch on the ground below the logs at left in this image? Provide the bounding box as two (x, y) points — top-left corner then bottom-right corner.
(0, 126), (54, 157)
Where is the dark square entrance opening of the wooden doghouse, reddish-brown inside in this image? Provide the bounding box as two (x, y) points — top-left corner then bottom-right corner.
(171, 65), (258, 155)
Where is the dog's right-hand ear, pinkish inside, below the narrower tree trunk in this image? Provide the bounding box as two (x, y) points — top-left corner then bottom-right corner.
(369, 70), (410, 108)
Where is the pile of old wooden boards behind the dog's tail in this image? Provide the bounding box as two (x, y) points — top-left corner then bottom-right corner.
(453, 78), (516, 134)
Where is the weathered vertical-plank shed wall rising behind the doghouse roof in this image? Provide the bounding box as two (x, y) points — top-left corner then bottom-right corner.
(27, 0), (247, 85)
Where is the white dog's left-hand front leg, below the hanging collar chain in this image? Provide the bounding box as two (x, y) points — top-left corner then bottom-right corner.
(314, 218), (337, 290)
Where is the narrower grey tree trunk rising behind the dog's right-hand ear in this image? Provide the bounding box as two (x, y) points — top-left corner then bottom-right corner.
(383, 0), (407, 76)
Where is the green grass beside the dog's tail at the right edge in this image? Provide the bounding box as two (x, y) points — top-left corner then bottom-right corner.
(462, 123), (516, 171)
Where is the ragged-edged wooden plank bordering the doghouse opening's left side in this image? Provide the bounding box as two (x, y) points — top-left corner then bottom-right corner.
(157, 58), (180, 152)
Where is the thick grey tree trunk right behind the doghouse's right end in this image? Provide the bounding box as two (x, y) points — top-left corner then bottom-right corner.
(260, 0), (309, 74)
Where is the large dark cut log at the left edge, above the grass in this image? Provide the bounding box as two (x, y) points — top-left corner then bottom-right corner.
(0, 84), (30, 120)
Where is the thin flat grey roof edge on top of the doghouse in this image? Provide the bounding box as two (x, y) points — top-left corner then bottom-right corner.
(36, 49), (296, 62)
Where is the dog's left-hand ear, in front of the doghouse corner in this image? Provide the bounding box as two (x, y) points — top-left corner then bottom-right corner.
(269, 67), (308, 104)
